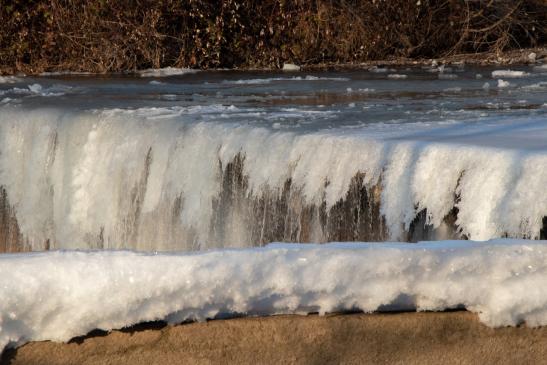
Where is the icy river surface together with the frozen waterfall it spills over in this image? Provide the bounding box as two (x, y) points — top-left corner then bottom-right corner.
(0, 65), (547, 251)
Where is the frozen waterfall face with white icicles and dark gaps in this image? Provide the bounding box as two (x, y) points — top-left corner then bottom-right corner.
(0, 106), (547, 251)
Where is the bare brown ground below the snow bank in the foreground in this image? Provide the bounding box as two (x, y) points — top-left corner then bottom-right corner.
(2, 311), (547, 365)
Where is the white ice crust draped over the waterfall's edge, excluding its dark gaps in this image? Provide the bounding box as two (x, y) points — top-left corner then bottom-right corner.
(0, 105), (547, 250)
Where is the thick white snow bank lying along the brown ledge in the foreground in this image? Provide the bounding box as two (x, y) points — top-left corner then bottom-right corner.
(0, 240), (547, 348)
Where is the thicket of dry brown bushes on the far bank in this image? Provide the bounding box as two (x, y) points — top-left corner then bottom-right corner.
(0, 0), (547, 72)
